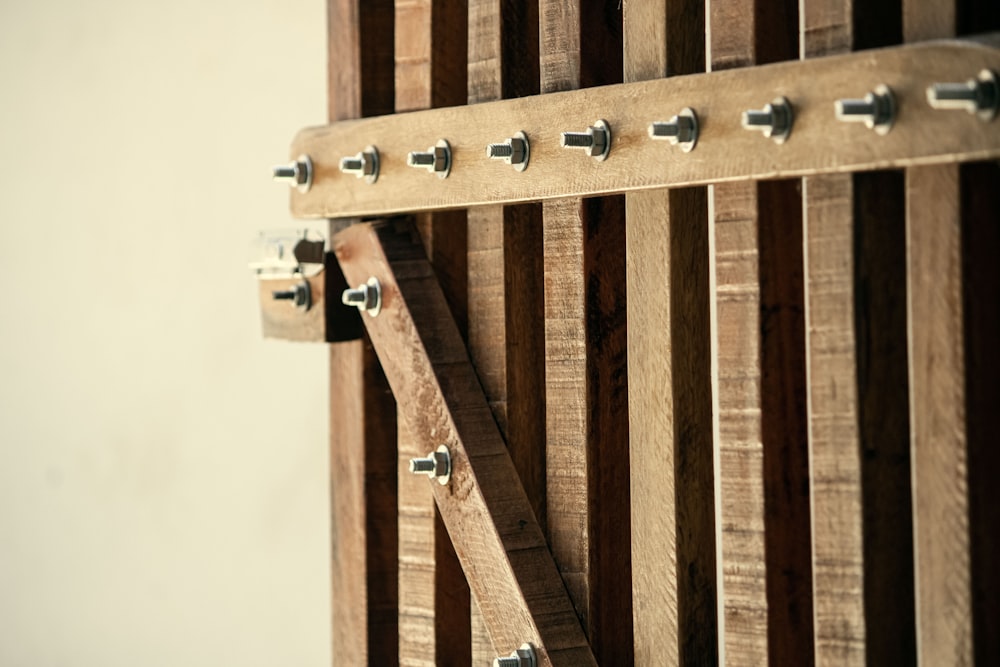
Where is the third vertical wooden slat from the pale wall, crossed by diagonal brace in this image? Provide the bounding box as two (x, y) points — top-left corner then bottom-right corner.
(468, 0), (545, 665)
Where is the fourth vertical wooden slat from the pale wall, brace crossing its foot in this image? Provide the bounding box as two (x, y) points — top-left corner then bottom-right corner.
(539, 0), (633, 664)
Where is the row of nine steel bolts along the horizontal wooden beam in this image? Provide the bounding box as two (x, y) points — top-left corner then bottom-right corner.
(274, 70), (1000, 192)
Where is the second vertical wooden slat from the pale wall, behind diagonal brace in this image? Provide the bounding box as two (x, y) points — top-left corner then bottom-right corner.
(395, 0), (471, 665)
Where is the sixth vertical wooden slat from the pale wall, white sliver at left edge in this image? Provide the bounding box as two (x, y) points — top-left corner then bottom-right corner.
(708, 0), (813, 665)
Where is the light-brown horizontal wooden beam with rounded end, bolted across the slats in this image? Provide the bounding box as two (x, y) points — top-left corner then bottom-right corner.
(291, 34), (1000, 218)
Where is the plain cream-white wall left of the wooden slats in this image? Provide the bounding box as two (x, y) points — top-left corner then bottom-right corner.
(0, 0), (330, 667)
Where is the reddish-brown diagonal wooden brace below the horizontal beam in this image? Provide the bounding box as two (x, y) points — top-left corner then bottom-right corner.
(333, 221), (596, 666)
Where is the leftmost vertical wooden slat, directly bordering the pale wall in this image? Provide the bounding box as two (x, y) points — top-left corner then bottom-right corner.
(327, 0), (398, 667)
